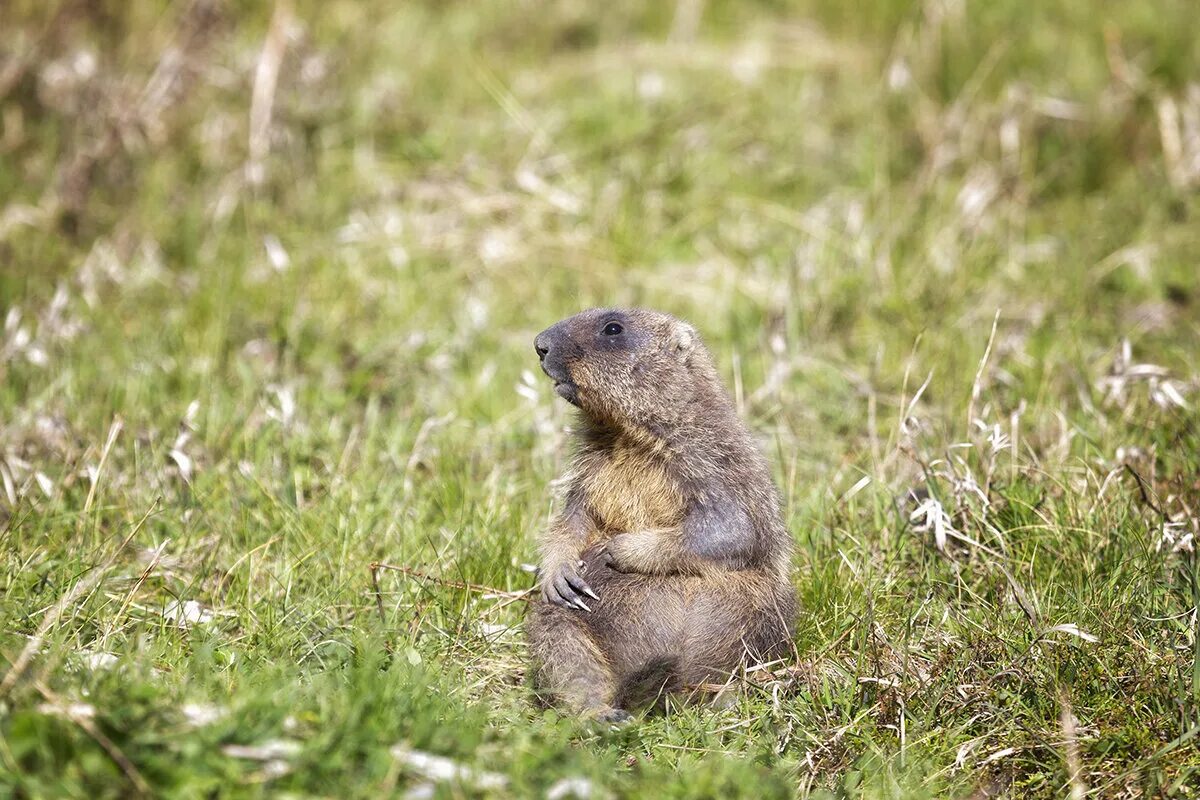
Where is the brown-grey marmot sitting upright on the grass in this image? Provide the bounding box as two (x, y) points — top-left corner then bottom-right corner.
(527, 308), (796, 722)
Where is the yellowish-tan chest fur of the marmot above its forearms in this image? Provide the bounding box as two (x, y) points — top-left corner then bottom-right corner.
(577, 443), (685, 539)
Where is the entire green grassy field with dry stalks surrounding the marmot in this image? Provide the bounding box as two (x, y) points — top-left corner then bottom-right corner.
(0, 0), (1200, 800)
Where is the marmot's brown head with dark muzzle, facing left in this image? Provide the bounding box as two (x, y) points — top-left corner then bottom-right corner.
(534, 308), (716, 427)
